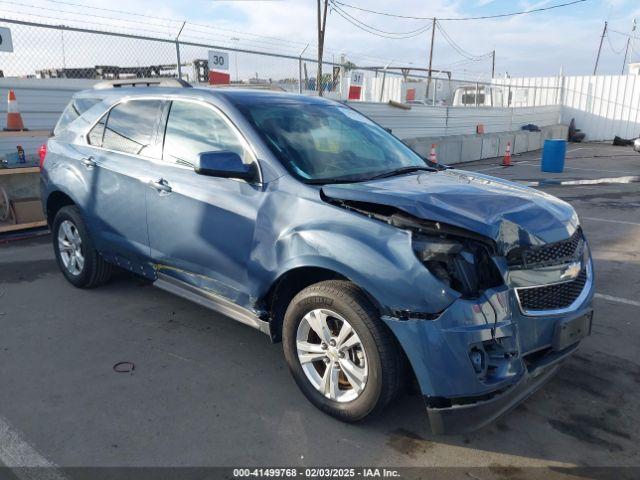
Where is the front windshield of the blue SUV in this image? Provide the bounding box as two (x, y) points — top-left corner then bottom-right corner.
(232, 103), (427, 183)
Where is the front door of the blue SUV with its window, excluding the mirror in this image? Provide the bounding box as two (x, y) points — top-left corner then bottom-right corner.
(146, 100), (264, 306)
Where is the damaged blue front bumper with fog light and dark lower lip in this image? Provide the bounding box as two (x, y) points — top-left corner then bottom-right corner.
(383, 280), (593, 433)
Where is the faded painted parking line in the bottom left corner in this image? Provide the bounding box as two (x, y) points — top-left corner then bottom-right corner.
(0, 416), (67, 480)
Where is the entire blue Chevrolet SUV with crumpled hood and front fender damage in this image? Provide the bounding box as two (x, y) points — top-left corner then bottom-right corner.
(41, 79), (593, 433)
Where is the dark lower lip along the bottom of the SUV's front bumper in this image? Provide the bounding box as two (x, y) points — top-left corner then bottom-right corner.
(427, 344), (579, 434)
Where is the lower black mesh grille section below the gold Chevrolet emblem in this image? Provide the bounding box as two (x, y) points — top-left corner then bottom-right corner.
(516, 268), (587, 312)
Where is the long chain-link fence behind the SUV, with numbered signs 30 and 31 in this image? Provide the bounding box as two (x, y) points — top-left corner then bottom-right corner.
(0, 18), (560, 107)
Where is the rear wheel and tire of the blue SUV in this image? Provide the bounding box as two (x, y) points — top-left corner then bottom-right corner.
(52, 205), (113, 288)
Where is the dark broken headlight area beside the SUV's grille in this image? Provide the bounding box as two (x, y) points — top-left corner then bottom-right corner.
(412, 233), (503, 298)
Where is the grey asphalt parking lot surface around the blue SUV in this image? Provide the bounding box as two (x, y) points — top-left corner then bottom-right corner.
(0, 144), (640, 478)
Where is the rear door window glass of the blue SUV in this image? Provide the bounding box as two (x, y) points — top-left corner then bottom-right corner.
(100, 100), (162, 158)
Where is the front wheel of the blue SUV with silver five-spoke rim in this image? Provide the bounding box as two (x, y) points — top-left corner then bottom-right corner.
(282, 280), (402, 422)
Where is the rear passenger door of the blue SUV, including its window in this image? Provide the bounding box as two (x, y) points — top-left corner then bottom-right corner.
(80, 99), (163, 273)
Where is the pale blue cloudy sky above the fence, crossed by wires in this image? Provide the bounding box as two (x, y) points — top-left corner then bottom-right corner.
(0, 0), (640, 77)
